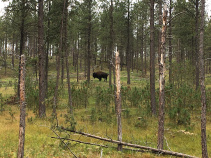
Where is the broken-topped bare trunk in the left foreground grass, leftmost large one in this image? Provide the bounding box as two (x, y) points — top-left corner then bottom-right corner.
(17, 55), (26, 158)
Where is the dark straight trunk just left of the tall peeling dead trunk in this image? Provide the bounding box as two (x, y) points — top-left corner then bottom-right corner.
(150, 0), (156, 115)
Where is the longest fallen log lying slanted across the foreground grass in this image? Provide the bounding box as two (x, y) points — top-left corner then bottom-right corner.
(61, 127), (196, 158)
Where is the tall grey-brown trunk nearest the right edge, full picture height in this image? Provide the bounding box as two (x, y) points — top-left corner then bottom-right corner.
(199, 0), (208, 158)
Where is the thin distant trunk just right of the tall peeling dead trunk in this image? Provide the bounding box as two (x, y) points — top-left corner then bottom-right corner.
(169, 0), (172, 84)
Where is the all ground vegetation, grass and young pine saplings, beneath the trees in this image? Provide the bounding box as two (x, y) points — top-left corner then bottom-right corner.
(0, 59), (211, 158)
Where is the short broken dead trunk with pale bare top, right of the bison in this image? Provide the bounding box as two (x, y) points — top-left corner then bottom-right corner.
(115, 51), (122, 151)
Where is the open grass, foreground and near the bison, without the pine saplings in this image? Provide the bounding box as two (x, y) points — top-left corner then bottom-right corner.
(0, 58), (211, 158)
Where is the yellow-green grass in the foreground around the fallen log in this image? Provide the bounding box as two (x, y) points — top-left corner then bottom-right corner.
(0, 106), (211, 157)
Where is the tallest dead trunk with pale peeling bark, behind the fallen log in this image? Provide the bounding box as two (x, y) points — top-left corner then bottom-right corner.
(158, 6), (168, 149)
